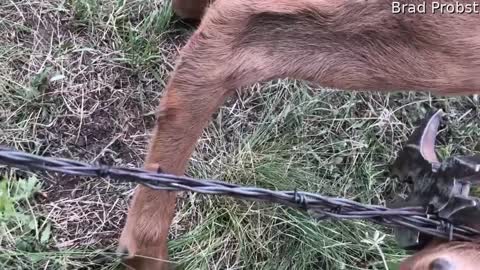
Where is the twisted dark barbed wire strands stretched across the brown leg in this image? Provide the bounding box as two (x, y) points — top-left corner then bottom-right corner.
(0, 146), (480, 241)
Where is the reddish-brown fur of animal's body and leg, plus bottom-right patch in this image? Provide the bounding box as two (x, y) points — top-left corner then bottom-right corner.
(120, 0), (480, 270)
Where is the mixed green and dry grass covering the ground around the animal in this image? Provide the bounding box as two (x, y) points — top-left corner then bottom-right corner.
(0, 0), (480, 270)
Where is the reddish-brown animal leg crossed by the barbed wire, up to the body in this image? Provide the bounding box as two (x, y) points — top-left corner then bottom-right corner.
(119, 7), (278, 269)
